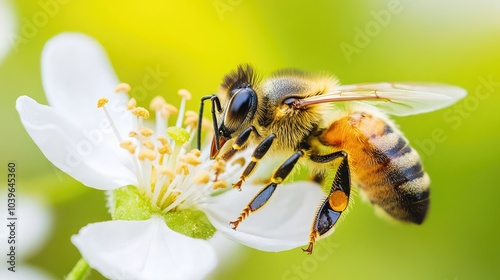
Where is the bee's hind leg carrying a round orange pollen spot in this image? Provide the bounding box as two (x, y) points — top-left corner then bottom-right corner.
(302, 151), (351, 254)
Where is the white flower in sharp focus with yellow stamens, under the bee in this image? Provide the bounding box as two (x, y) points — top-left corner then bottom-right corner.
(17, 33), (324, 279)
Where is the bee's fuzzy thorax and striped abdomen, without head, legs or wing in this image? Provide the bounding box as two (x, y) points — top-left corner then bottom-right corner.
(221, 70), (429, 224)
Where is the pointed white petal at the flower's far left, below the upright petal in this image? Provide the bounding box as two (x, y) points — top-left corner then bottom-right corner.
(16, 96), (137, 190)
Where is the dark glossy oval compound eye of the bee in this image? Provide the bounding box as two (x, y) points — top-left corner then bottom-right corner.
(225, 87), (257, 132)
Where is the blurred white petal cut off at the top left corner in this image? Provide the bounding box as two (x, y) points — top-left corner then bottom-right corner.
(0, 0), (15, 61)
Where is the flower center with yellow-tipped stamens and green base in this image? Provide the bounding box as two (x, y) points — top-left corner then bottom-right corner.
(97, 84), (250, 239)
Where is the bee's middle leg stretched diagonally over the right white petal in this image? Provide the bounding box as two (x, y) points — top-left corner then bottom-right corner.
(229, 151), (304, 230)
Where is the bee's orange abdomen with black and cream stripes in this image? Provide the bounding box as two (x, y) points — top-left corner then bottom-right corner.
(320, 112), (430, 224)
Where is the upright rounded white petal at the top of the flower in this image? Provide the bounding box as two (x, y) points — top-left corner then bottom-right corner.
(42, 33), (130, 140)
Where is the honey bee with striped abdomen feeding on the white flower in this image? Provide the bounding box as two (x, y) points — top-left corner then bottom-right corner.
(198, 65), (466, 254)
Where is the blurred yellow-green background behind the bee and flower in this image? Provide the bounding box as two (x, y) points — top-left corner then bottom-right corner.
(0, 0), (500, 279)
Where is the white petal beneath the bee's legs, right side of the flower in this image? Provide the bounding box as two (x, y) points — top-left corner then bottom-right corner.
(202, 181), (326, 251)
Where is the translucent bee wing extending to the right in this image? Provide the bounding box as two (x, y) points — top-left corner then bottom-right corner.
(298, 83), (467, 116)
